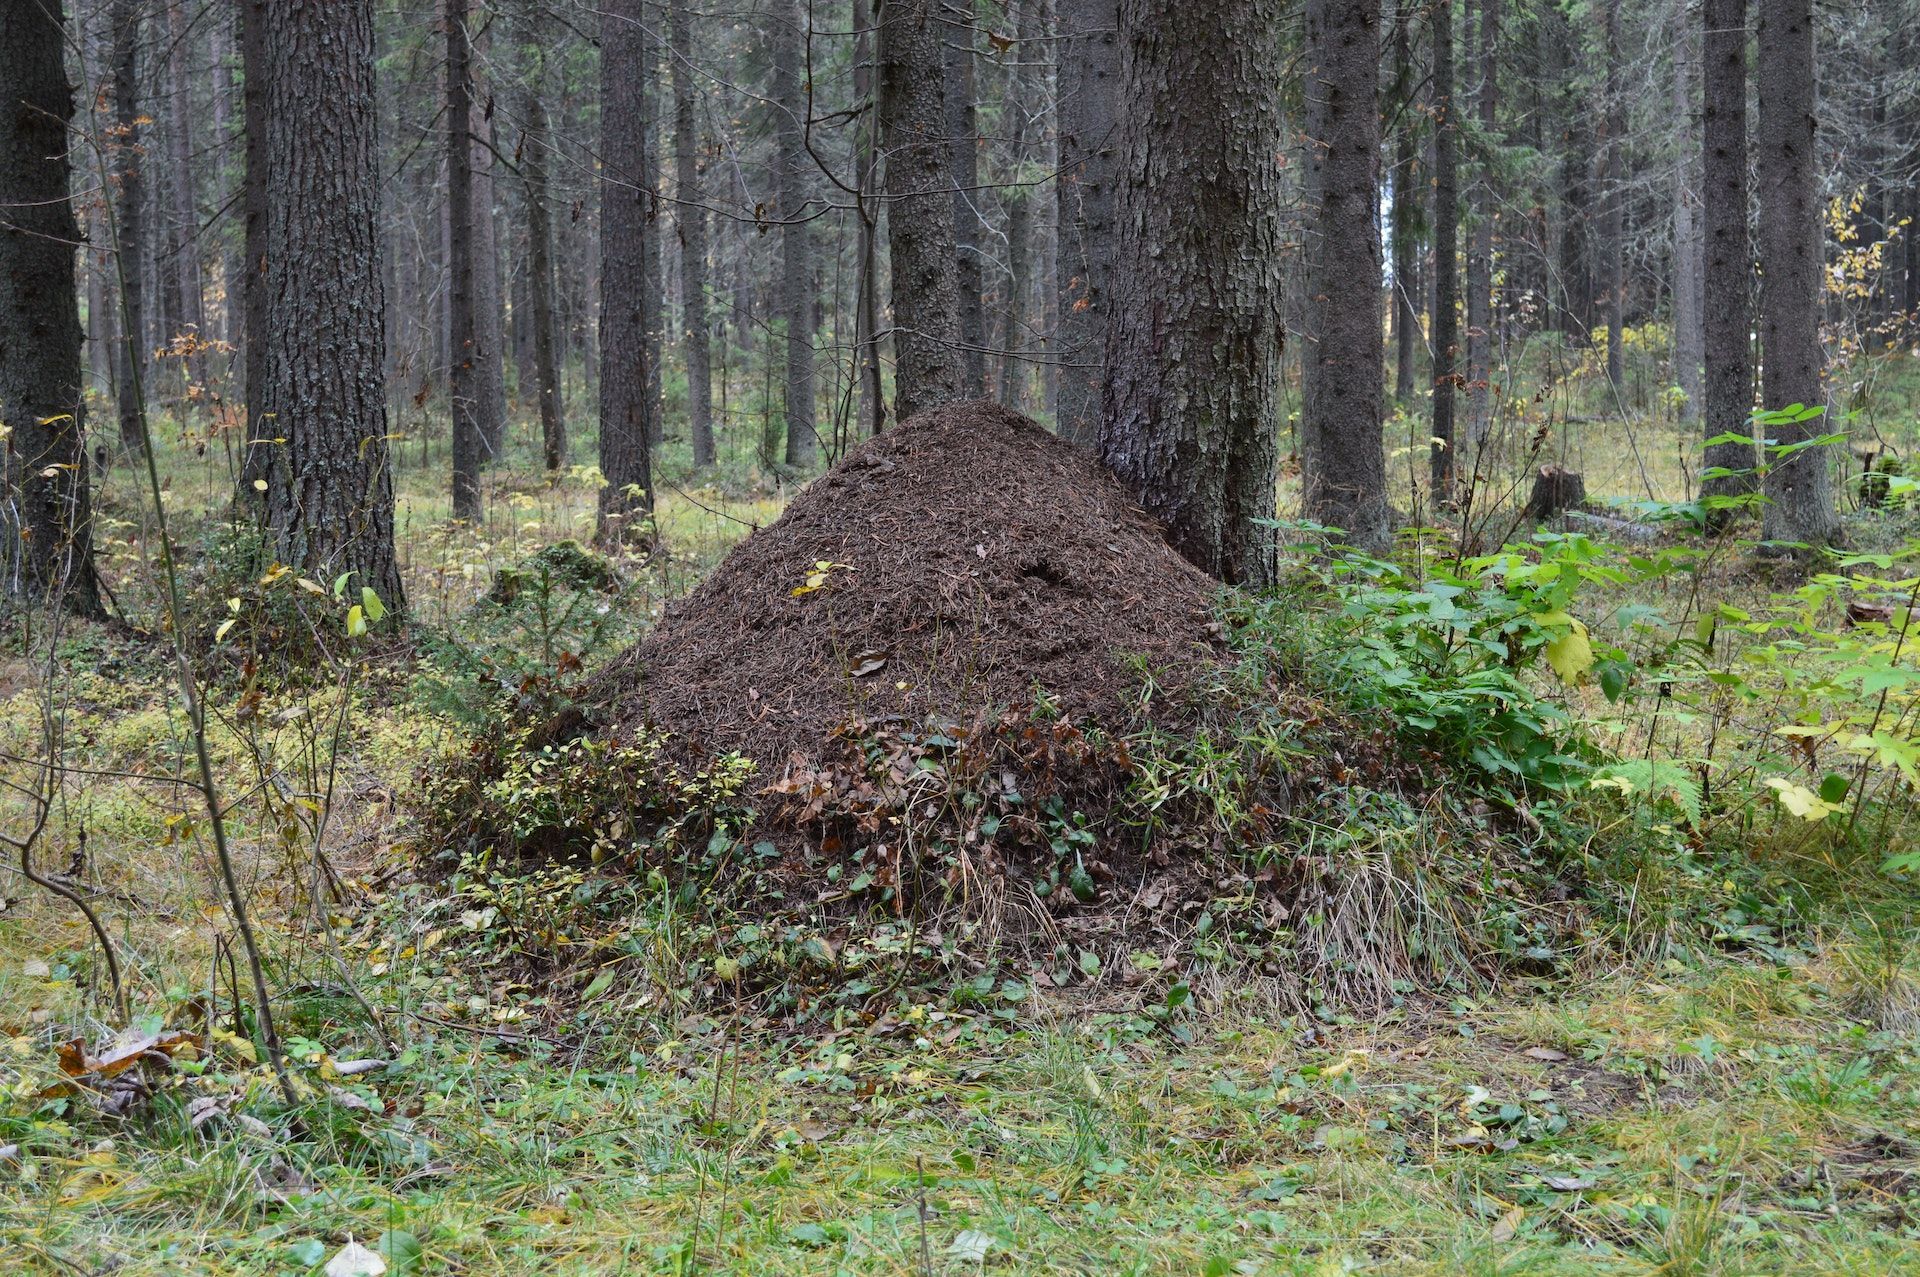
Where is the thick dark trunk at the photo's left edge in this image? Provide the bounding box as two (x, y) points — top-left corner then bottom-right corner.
(0, 0), (102, 616)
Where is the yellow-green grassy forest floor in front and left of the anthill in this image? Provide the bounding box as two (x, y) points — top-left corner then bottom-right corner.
(0, 395), (1920, 1277)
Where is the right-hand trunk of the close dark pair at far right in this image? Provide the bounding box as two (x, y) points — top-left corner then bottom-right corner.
(1755, 0), (1839, 547)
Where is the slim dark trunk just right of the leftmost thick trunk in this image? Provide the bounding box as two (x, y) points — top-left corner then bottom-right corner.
(111, 0), (146, 453)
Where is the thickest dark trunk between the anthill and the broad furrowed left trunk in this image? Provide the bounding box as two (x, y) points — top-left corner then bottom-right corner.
(595, 0), (655, 545)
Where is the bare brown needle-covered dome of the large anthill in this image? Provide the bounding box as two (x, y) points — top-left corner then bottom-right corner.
(588, 401), (1217, 783)
